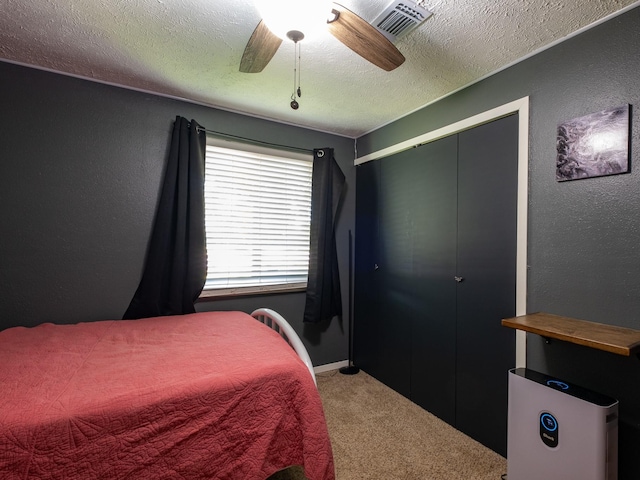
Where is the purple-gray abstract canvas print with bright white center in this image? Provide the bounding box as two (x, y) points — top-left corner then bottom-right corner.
(556, 105), (629, 182)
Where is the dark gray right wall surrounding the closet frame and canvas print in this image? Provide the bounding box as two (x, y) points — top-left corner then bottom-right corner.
(357, 8), (640, 480)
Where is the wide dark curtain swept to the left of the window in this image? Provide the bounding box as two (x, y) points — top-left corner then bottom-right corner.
(123, 117), (207, 319)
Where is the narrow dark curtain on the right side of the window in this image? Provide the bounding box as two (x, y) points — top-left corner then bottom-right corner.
(303, 148), (345, 323)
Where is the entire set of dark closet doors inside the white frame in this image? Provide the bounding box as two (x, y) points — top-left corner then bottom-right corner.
(354, 116), (518, 455)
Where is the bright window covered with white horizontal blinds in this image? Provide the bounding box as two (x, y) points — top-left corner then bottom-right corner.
(201, 137), (313, 297)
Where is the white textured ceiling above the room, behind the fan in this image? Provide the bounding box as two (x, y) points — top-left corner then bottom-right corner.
(0, 0), (639, 137)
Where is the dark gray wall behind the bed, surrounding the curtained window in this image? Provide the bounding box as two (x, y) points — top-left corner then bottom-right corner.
(0, 62), (355, 365)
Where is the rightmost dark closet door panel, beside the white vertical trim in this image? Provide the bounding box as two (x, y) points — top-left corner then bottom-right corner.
(455, 115), (518, 455)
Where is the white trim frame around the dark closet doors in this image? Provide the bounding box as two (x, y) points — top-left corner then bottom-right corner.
(354, 97), (529, 367)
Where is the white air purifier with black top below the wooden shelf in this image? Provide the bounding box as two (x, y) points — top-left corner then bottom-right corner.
(507, 368), (618, 480)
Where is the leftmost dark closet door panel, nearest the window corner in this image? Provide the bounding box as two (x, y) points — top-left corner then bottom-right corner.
(354, 160), (412, 397)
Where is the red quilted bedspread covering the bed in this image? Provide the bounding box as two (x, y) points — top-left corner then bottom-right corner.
(0, 312), (334, 480)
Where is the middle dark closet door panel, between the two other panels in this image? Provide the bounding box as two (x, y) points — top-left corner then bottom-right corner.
(409, 135), (458, 425)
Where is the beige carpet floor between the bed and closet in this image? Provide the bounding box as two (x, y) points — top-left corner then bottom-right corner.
(268, 370), (507, 480)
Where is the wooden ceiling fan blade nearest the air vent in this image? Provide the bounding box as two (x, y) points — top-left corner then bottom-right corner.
(327, 3), (404, 72)
